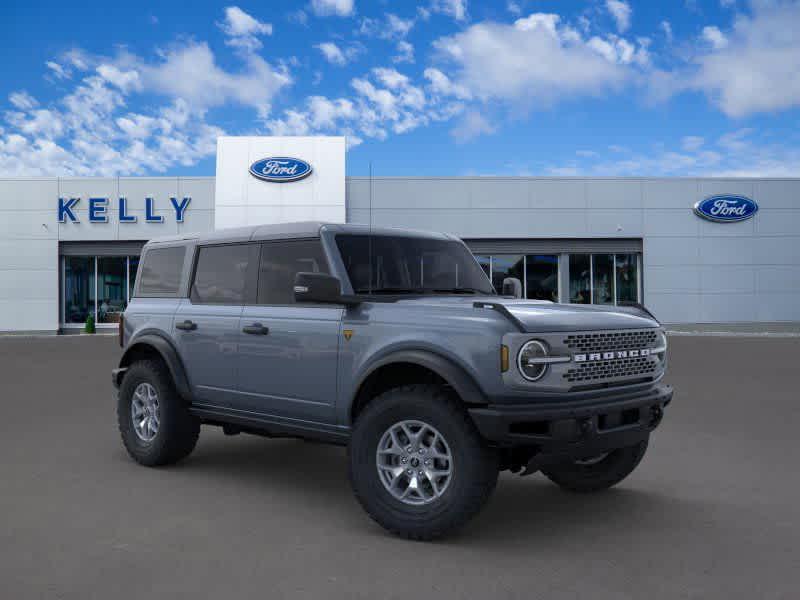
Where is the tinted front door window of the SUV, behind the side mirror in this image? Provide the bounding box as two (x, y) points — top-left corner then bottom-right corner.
(258, 240), (329, 304)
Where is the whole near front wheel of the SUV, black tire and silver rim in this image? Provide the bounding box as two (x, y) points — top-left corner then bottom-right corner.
(349, 385), (498, 540)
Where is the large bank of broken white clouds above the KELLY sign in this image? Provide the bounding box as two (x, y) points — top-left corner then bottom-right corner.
(0, 31), (291, 176)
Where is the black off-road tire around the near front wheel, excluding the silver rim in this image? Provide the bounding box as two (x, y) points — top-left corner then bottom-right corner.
(348, 385), (498, 540)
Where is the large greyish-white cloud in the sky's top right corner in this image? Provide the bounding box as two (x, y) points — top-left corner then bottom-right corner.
(692, 1), (800, 117)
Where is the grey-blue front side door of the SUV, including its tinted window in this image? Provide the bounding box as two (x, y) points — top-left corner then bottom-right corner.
(235, 239), (344, 423)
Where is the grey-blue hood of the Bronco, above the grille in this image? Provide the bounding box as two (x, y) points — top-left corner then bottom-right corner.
(390, 296), (659, 333)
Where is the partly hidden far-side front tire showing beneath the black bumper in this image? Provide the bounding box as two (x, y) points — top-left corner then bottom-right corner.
(542, 439), (648, 493)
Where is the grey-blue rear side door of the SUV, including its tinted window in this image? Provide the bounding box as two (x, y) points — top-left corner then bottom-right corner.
(174, 243), (258, 407)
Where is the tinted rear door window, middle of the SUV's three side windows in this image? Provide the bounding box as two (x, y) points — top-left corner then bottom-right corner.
(191, 244), (250, 304)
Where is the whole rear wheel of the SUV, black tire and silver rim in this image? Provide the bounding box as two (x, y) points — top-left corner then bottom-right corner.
(117, 360), (200, 467)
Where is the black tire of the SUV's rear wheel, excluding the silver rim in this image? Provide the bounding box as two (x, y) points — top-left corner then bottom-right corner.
(117, 360), (200, 467)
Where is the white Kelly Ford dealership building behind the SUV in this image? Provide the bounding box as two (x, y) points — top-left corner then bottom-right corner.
(0, 137), (800, 333)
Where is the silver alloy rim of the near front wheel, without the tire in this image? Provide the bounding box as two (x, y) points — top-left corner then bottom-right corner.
(375, 421), (453, 506)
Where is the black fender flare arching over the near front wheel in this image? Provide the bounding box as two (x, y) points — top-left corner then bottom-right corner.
(348, 350), (488, 420)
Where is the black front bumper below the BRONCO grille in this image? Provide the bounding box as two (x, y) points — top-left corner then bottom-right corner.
(469, 384), (672, 458)
